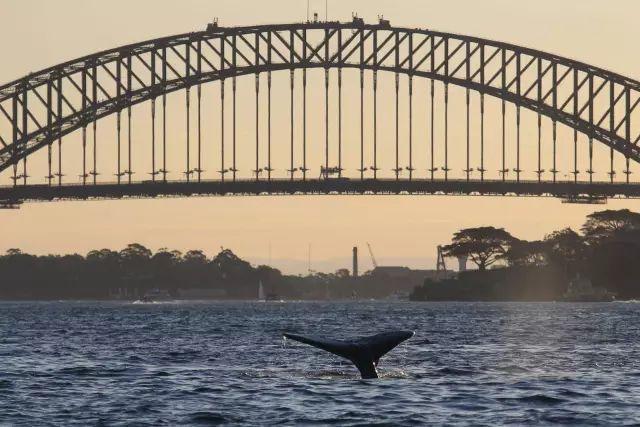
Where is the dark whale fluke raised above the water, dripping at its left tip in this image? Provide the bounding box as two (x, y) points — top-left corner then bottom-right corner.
(283, 331), (415, 378)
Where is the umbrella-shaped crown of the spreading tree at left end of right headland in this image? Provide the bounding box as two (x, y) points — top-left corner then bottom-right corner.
(443, 227), (516, 271)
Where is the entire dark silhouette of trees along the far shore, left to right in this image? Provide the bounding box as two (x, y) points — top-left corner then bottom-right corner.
(6, 209), (640, 300)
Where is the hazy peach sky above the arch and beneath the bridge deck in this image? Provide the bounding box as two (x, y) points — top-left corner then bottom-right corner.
(0, 0), (640, 271)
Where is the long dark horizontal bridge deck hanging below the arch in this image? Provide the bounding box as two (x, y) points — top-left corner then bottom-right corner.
(0, 178), (640, 205)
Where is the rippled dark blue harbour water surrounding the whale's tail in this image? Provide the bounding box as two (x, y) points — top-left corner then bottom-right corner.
(0, 302), (640, 426)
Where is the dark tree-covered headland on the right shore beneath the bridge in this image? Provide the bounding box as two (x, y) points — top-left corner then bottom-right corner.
(416, 209), (640, 299)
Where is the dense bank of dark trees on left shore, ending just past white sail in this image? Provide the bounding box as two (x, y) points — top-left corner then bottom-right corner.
(0, 243), (281, 298)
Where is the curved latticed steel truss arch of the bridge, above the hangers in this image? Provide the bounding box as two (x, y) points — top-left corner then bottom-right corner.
(0, 19), (640, 179)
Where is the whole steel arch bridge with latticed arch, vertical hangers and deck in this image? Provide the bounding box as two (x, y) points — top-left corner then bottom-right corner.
(0, 17), (640, 205)
